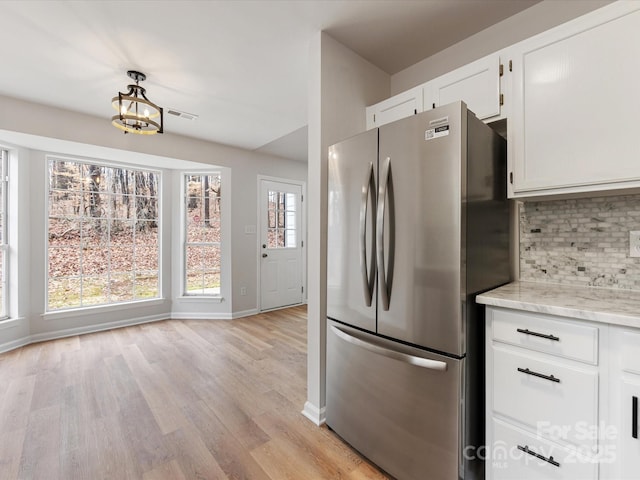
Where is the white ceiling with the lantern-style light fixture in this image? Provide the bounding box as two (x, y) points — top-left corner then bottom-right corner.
(0, 0), (538, 160)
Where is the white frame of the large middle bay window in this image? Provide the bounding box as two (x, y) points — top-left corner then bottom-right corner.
(44, 154), (164, 317)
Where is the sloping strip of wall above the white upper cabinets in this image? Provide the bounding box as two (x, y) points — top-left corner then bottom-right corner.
(390, 0), (611, 95)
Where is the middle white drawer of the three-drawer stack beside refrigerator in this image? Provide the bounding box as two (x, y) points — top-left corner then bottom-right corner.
(493, 345), (598, 449)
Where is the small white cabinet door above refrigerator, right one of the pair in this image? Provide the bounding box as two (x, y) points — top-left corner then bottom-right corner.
(432, 55), (500, 119)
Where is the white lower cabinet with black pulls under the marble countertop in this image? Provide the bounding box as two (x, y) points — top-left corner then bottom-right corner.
(483, 306), (640, 480)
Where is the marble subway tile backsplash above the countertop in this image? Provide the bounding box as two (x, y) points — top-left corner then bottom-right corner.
(519, 195), (640, 290)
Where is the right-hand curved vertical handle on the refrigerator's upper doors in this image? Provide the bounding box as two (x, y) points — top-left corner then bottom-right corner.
(376, 157), (394, 311)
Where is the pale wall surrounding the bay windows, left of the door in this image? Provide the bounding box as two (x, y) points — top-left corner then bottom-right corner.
(0, 96), (307, 351)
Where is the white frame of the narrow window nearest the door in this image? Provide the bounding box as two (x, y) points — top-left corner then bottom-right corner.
(180, 169), (222, 294)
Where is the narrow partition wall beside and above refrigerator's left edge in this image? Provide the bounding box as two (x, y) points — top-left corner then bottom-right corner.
(303, 33), (390, 424)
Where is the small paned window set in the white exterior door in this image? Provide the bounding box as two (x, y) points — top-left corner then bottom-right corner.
(267, 190), (297, 248)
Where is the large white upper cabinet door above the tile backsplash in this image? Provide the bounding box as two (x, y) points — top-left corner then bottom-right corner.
(510, 2), (640, 196)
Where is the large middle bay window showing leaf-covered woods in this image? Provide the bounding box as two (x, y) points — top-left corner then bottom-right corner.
(47, 158), (161, 310)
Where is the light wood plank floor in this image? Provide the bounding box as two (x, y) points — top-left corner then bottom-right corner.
(0, 307), (388, 480)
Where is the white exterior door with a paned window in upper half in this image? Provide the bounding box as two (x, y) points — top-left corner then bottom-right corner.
(259, 180), (303, 310)
